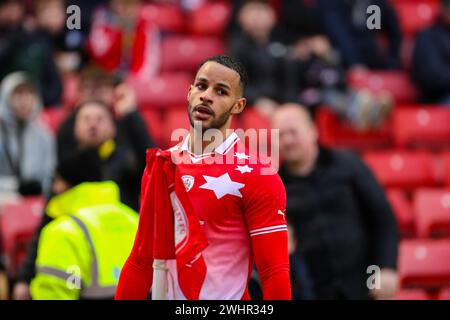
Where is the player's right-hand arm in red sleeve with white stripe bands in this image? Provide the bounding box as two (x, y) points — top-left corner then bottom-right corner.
(245, 170), (292, 300)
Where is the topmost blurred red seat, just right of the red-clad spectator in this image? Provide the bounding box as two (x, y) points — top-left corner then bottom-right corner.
(140, 3), (185, 32)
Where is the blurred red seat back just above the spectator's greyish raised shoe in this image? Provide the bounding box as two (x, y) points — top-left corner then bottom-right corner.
(347, 70), (417, 103)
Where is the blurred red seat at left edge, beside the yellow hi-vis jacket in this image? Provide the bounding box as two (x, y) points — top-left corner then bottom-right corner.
(0, 197), (44, 272)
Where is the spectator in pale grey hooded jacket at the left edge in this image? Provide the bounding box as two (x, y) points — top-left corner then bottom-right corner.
(0, 72), (56, 200)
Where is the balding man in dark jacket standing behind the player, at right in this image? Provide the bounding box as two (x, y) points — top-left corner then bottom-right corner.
(274, 104), (398, 299)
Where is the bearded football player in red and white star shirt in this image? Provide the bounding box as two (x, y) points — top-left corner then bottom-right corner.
(115, 56), (291, 300)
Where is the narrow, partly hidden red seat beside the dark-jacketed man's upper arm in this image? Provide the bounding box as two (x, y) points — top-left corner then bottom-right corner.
(386, 189), (415, 237)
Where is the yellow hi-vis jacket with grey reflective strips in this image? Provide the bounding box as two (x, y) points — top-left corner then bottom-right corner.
(30, 181), (138, 299)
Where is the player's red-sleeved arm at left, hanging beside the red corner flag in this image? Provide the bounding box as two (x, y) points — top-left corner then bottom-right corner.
(115, 168), (153, 300)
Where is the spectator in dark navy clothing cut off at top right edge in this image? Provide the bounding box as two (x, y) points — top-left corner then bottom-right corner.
(412, 0), (450, 105)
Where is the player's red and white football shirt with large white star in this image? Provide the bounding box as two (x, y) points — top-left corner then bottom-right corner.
(163, 133), (287, 300)
